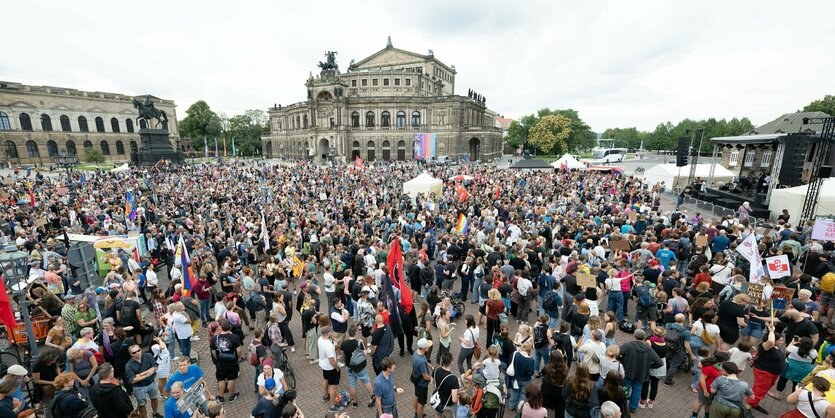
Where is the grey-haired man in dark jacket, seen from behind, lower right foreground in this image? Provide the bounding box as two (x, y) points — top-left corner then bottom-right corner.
(620, 329), (664, 412)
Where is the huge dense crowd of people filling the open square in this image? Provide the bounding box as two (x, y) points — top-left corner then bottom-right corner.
(0, 158), (835, 418)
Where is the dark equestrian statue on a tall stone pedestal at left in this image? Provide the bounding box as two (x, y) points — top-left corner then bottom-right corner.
(131, 96), (183, 166)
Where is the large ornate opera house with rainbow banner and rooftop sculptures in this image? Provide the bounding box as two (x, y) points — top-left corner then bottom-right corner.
(262, 40), (502, 162)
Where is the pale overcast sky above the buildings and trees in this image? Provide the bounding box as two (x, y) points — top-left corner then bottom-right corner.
(0, 0), (835, 132)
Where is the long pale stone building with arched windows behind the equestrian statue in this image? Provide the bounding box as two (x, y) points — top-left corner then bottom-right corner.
(0, 81), (179, 165)
